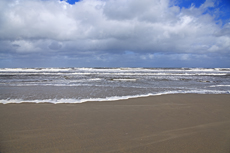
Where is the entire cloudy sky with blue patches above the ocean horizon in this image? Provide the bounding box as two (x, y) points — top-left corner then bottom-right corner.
(0, 0), (230, 68)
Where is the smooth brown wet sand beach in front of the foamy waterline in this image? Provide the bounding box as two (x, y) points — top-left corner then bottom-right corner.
(0, 94), (230, 153)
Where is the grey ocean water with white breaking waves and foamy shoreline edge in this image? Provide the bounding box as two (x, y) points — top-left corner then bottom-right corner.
(0, 68), (230, 104)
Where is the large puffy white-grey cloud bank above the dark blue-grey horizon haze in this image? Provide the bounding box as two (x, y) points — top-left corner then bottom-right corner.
(0, 0), (230, 67)
